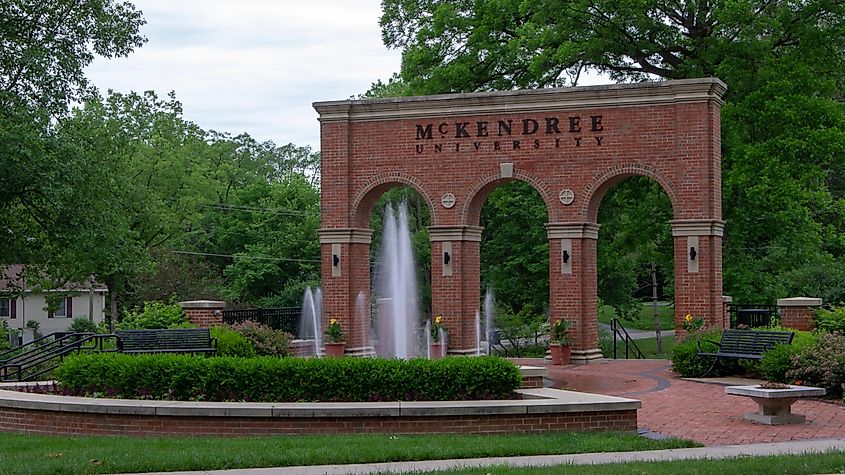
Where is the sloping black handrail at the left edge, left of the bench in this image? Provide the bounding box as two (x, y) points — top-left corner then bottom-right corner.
(0, 333), (117, 381)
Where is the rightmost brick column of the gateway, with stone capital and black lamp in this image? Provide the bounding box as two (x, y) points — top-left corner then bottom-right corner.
(672, 219), (725, 332)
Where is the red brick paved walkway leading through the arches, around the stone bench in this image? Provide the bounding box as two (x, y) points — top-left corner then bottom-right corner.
(522, 360), (845, 445)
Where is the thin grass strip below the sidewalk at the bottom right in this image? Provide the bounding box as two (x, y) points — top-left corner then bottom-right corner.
(398, 452), (845, 475)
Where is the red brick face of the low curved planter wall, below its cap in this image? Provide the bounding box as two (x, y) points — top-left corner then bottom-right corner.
(0, 408), (637, 436)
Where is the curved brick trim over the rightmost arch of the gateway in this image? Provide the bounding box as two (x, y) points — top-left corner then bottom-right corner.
(578, 163), (681, 223)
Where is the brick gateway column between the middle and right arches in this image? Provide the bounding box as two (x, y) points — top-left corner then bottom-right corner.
(546, 223), (603, 364)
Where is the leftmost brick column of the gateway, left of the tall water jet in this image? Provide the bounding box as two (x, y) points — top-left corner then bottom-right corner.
(318, 228), (375, 356)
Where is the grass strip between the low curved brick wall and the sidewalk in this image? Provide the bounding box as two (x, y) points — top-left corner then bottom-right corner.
(0, 432), (697, 475)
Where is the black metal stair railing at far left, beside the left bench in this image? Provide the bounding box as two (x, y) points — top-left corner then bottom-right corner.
(0, 332), (117, 382)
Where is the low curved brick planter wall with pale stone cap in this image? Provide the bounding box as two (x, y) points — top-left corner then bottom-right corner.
(0, 384), (641, 436)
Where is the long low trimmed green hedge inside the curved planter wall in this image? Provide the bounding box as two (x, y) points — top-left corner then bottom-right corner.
(55, 353), (521, 402)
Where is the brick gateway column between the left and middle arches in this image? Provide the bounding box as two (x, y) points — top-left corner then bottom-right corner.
(428, 226), (484, 355)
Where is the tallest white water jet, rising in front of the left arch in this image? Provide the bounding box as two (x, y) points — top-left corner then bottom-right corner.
(374, 202), (420, 359)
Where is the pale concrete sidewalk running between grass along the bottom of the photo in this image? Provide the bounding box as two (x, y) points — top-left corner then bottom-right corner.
(139, 439), (845, 475)
